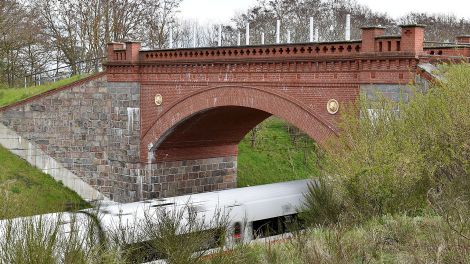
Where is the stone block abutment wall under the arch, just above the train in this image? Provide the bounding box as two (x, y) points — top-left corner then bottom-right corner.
(116, 156), (237, 201)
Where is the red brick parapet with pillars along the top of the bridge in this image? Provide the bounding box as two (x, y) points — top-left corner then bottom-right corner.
(107, 25), (468, 68)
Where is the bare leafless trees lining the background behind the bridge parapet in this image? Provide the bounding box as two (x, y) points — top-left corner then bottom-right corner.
(0, 0), (470, 86)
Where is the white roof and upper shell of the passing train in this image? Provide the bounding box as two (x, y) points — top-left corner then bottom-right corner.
(0, 180), (310, 241)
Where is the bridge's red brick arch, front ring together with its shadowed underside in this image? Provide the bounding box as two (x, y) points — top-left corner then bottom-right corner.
(141, 86), (336, 162)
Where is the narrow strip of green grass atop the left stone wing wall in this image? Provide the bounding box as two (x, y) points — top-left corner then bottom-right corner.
(0, 75), (86, 107)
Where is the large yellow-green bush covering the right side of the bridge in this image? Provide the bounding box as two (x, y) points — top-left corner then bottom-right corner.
(310, 64), (470, 221)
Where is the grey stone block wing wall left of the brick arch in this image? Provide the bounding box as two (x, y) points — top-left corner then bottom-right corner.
(0, 76), (113, 194)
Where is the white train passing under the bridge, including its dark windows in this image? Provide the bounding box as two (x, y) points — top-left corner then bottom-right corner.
(0, 180), (310, 260)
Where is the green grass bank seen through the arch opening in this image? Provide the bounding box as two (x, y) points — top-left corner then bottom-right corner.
(237, 117), (319, 187)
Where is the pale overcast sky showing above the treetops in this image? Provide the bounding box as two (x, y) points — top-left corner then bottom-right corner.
(180, 0), (470, 23)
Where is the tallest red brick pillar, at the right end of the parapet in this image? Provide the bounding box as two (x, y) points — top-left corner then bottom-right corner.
(400, 25), (425, 54)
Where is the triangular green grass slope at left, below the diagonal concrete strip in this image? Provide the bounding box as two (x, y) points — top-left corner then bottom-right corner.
(0, 146), (88, 219)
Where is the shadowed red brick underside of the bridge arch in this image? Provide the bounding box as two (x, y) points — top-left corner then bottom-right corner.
(154, 106), (271, 162)
